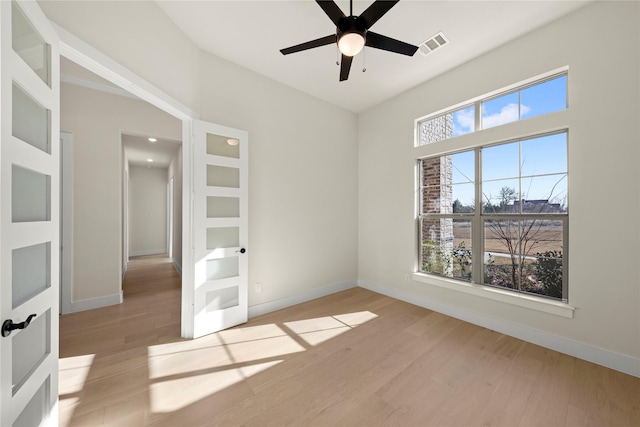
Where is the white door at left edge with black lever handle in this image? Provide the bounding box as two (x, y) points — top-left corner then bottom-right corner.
(0, 1), (60, 426)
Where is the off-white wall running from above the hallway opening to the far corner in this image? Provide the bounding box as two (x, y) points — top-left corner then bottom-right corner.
(45, 1), (358, 313)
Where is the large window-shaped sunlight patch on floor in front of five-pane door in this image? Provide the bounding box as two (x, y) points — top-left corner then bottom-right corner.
(148, 311), (378, 413)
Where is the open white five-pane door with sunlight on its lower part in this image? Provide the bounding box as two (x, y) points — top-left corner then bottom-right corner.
(186, 121), (248, 337)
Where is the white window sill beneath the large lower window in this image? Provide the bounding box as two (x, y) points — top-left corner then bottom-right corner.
(413, 273), (575, 319)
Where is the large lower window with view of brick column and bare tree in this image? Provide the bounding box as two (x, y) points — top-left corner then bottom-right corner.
(419, 131), (568, 302)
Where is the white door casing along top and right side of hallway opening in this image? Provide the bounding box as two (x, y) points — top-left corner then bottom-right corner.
(51, 22), (199, 337)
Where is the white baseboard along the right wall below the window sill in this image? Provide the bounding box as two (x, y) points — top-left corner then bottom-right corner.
(358, 280), (640, 377)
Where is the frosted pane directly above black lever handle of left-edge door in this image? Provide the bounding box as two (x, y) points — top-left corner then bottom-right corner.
(11, 242), (51, 308)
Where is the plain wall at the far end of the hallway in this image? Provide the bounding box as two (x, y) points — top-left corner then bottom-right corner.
(129, 164), (169, 256)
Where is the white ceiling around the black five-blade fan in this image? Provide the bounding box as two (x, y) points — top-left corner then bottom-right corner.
(156, 0), (591, 112)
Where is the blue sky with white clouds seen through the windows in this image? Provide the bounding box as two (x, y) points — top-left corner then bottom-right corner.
(453, 76), (567, 211)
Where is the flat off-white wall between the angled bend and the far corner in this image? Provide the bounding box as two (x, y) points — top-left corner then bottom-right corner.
(199, 53), (358, 306)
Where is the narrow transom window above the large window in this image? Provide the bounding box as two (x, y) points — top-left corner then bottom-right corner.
(416, 72), (567, 146)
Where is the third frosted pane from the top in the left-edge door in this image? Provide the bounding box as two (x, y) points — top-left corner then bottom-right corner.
(11, 165), (51, 222)
